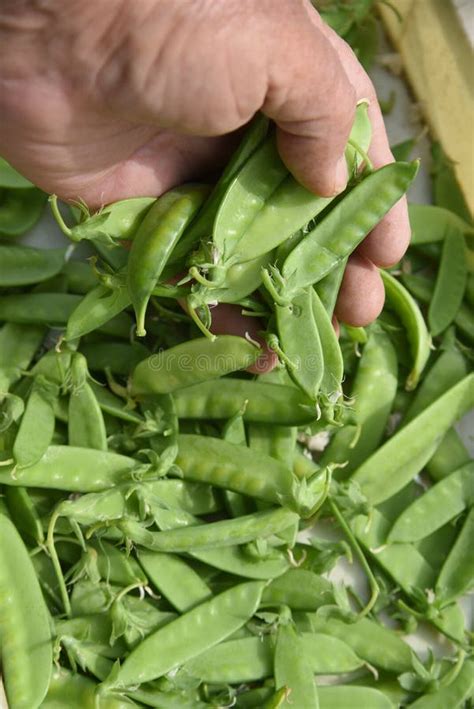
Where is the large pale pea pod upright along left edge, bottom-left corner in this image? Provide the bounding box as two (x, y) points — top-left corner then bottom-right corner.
(0, 514), (53, 709)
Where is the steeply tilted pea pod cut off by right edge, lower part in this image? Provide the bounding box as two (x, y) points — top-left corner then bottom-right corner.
(435, 507), (474, 605)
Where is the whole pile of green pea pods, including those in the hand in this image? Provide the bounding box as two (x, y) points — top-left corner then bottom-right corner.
(0, 2), (474, 709)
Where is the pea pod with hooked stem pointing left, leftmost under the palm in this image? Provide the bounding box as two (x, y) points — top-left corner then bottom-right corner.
(49, 195), (156, 244)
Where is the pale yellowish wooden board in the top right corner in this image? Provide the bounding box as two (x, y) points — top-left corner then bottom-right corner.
(379, 0), (474, 213)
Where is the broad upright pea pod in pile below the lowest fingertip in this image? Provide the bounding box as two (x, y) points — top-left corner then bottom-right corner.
(320, 330), (398, 478)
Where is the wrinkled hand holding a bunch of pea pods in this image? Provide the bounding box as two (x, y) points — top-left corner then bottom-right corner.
(0, 0), (409, 366)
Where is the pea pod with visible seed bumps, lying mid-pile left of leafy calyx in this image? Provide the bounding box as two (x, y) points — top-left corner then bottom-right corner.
(176, 434), (295, 504)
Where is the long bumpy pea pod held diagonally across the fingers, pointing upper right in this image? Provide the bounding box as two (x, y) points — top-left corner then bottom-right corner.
(281, 162), (419, 292)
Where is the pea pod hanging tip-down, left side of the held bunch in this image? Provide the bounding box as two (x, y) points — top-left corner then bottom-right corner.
(127, 187), (206, 337)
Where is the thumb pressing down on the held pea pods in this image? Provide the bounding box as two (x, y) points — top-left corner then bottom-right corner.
(262, 0), (356, 196)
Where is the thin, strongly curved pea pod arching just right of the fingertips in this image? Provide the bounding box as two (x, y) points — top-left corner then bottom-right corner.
(379, 269), (431, 391)
